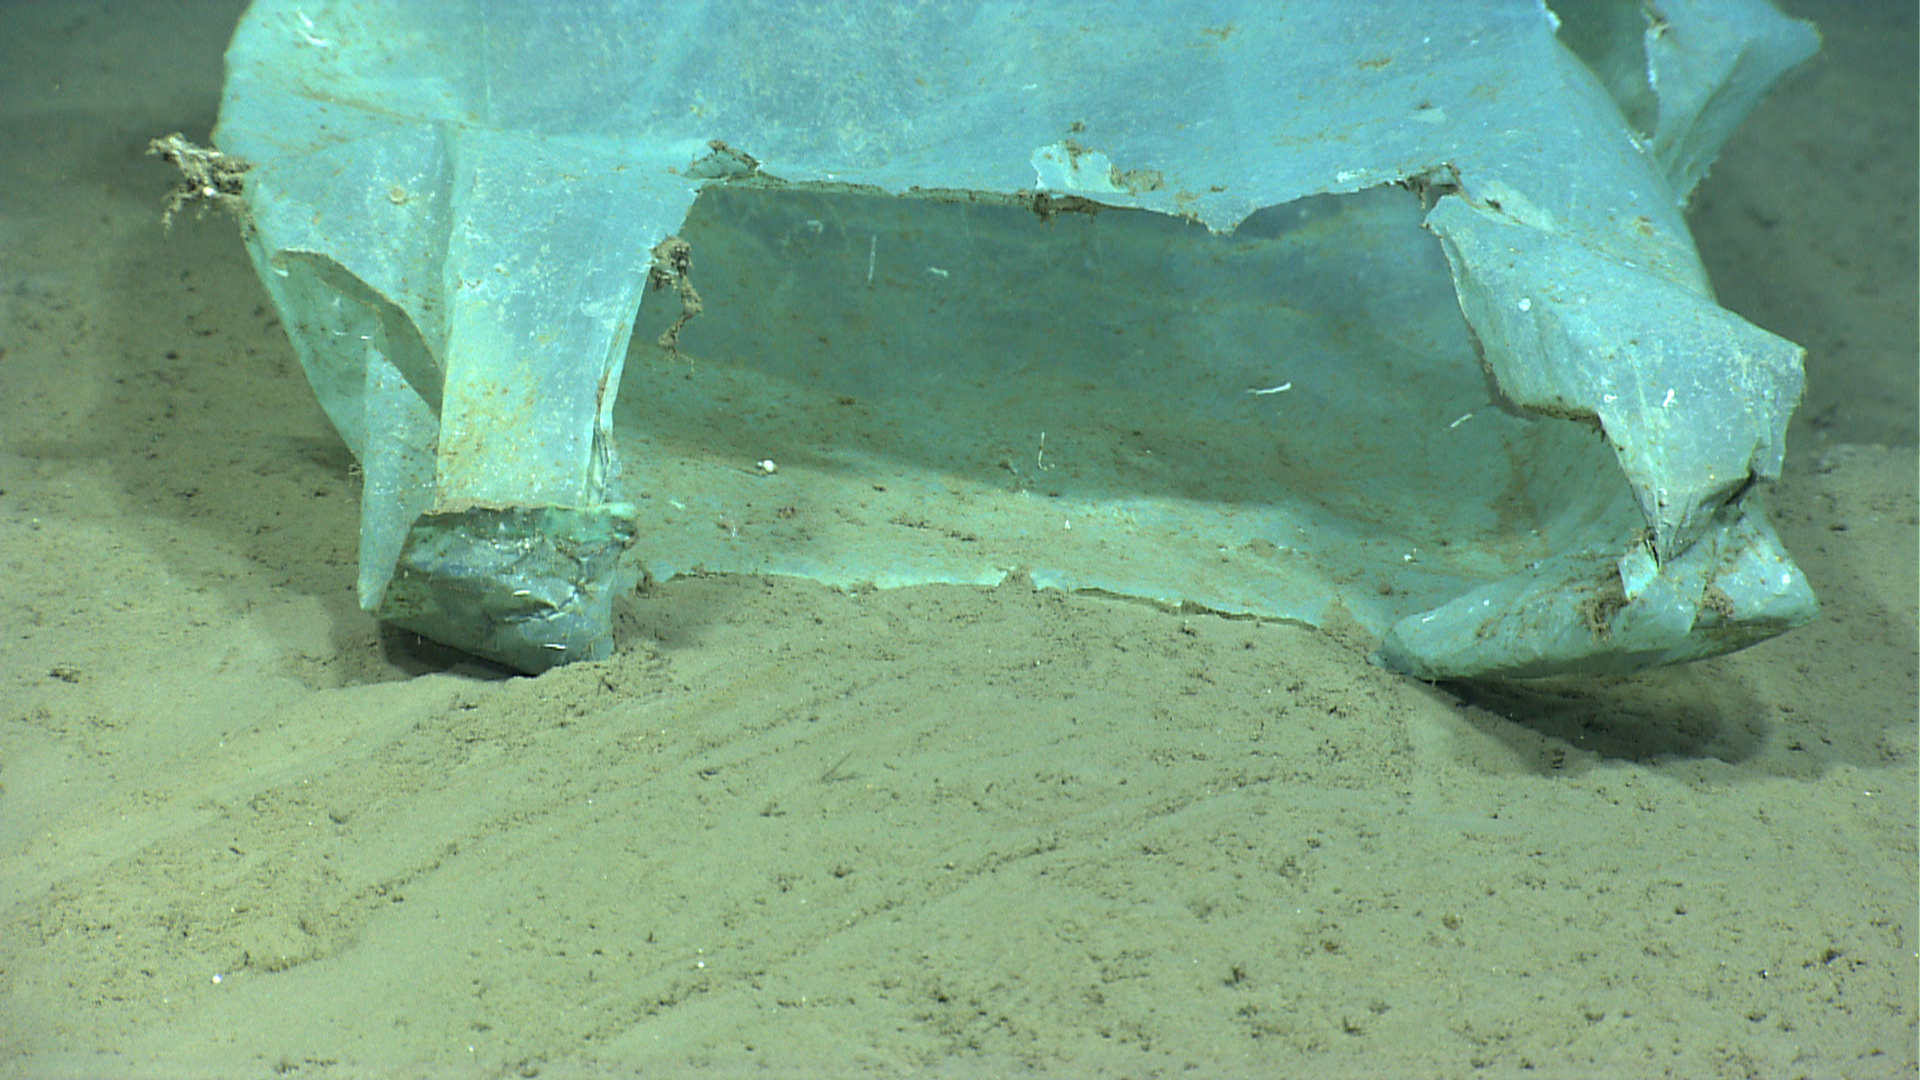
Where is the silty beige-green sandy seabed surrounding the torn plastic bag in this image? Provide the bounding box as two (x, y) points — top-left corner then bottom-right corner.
(0, 0), (1920, 1078)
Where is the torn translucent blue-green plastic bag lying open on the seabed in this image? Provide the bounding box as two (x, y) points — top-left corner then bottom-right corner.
(206, 0), (1816, 678)
